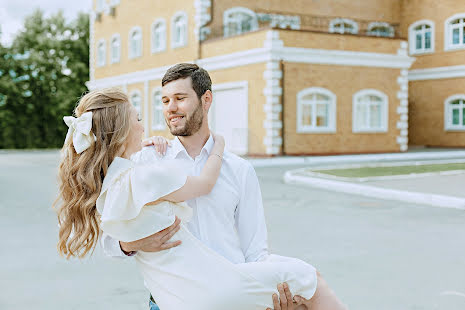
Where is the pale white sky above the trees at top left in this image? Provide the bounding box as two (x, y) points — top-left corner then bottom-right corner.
(0, 0), (92, 45)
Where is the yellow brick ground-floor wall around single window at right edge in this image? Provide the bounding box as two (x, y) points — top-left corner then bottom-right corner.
(409, 78), (465, 147)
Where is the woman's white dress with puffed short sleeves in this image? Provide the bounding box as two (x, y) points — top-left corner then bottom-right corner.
(97, 157), (317, 310)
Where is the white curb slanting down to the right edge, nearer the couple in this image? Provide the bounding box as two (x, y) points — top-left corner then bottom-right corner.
(283, 170), (465, 210)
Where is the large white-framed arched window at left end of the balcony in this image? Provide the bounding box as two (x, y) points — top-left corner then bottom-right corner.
(223, 7), (258, 37)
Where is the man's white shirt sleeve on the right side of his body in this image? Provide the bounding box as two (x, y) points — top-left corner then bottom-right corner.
(235, 162), (268, 262)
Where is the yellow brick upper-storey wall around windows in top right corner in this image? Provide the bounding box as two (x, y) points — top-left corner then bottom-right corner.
(400, 0), (465, 69)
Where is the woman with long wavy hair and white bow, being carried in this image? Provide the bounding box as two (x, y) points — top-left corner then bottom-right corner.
(58, 89), (344, 310)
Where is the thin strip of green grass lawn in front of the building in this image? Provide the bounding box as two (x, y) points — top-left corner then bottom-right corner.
(311, 163), (465, 178)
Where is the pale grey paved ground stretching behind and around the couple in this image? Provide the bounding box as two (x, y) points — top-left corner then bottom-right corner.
(0, 152), (465, 310)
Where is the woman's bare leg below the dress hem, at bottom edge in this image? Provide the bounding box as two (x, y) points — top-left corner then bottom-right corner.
(297, 272), (347, 310)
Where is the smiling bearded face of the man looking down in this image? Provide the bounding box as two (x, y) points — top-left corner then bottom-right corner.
(161, 77), (204, 136)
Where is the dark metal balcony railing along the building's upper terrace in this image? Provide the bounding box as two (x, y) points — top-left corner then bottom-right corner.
(201, 12), (400, 41)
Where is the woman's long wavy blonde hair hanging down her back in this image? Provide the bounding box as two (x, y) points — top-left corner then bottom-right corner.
(53, 88), (131, 259)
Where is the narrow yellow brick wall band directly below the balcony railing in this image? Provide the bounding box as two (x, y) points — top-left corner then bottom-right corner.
(279, 30), (402, 54)
